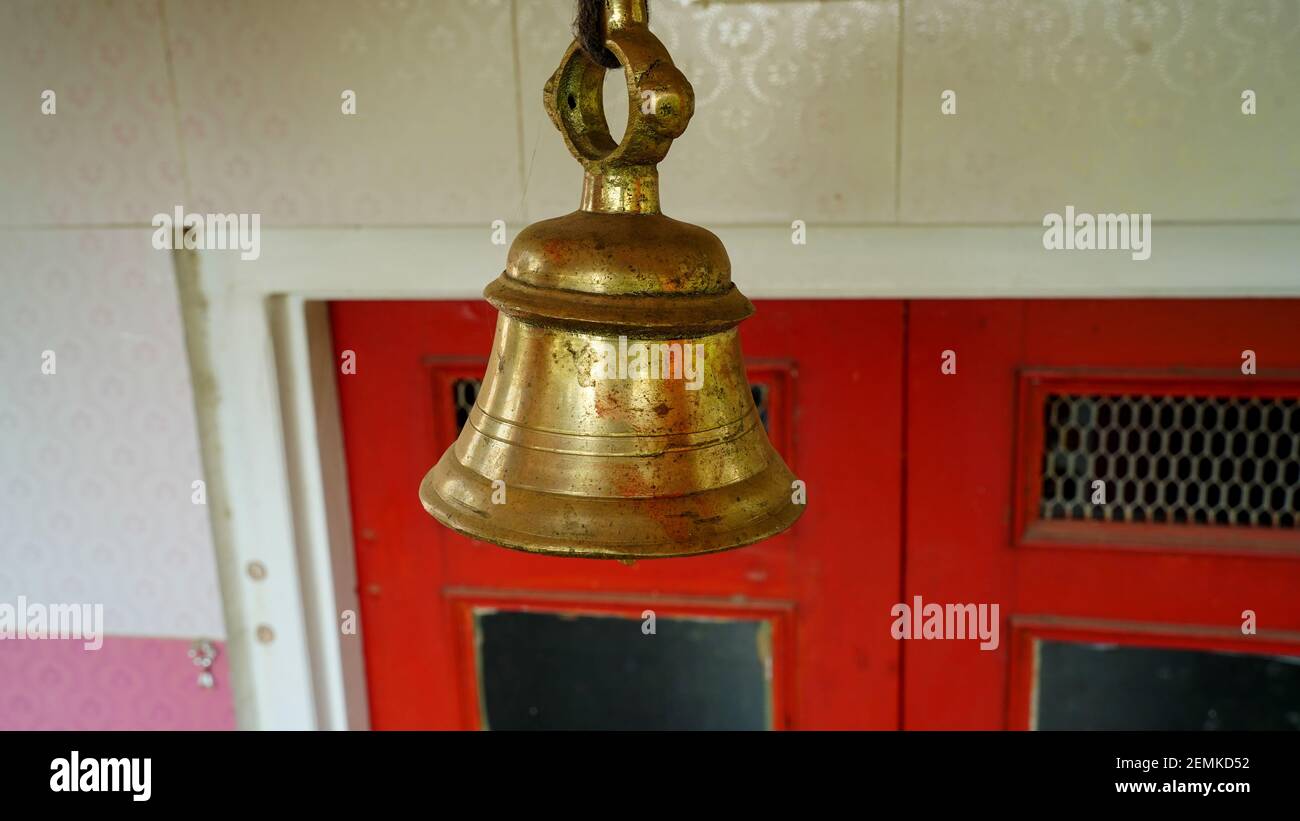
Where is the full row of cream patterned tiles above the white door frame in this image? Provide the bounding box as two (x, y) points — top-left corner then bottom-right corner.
(0, 0), (1300, 226)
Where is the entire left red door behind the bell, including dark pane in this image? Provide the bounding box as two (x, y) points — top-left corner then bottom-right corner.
(333, 301), (904, 727)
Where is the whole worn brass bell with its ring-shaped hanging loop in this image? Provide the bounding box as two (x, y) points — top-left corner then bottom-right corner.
(420, 0), (802, 560)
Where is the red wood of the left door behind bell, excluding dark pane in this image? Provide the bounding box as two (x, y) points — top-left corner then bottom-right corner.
(332, 301), (904, 729)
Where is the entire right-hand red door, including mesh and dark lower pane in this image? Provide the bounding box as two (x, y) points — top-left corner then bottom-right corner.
(904, 300), (1300, 729)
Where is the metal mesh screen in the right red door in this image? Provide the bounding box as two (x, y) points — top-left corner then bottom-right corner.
(1039, 394), (1300, 527)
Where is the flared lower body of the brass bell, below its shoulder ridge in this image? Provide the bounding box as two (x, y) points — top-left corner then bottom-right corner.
(420, 314), (802, 559)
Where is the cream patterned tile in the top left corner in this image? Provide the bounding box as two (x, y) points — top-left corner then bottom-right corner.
(0, 0), (183, 226)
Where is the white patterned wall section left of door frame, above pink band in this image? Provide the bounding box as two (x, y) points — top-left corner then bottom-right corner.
(0, 229), (224, 638)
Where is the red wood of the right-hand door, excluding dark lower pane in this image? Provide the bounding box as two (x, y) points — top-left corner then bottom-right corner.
(904, 300), (1300, 729)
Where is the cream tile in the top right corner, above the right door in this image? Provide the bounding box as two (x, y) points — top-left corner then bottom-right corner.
(901, 0), (1300, 222)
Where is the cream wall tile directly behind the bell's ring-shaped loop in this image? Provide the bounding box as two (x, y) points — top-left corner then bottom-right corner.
(519, 0), (898, 225)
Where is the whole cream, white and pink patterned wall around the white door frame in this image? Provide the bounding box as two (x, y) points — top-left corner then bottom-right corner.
(0, 0), (1300, 726)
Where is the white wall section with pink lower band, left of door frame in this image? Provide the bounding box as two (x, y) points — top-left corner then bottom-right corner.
(0, 229), (233, 729)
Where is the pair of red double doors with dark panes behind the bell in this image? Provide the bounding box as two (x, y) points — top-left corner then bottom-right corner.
(333, 300), (1300, 729)
